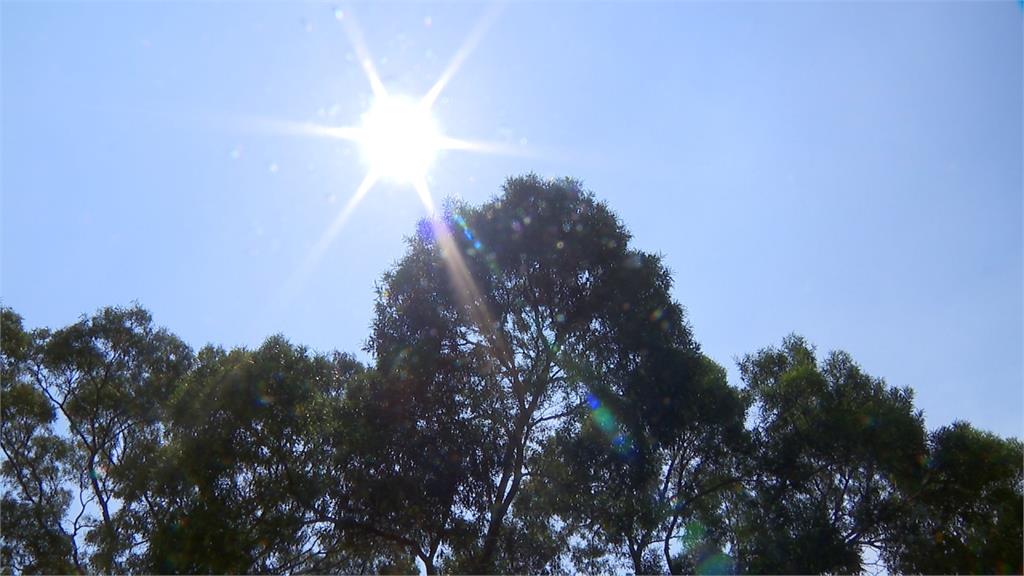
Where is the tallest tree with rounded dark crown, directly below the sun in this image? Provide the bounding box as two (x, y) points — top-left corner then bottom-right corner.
(370, 176), (724, 572)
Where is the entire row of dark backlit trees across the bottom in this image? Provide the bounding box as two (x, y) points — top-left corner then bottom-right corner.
(0, 176), (1024, 574)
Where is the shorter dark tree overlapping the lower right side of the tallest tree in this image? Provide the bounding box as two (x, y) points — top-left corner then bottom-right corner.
(546, 354), (748, 573)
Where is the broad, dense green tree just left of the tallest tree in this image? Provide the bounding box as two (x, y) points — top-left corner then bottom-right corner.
(139, 336), (376, 573)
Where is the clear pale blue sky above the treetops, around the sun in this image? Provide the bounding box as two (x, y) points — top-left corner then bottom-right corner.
(0, 1), (1024, 436)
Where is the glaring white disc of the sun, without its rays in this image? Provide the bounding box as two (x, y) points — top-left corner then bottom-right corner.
(356, 94), (443, 183)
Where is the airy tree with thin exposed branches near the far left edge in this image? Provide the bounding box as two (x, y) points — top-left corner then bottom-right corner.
(5, 306), (191, 572)
